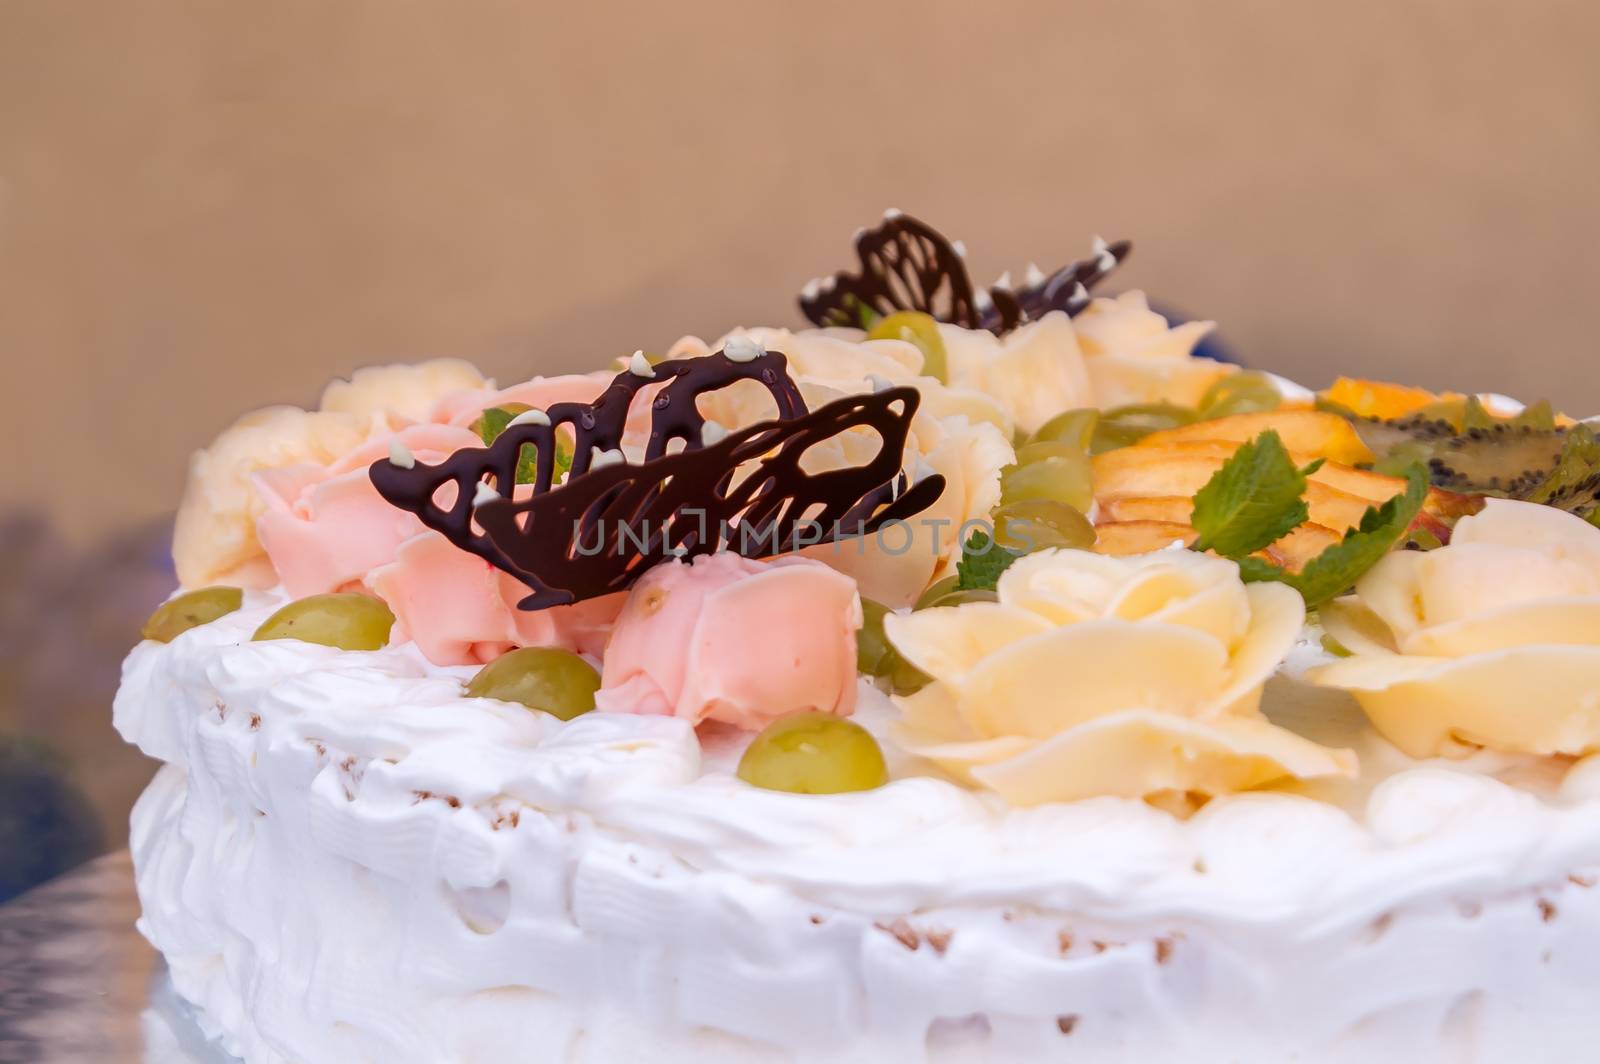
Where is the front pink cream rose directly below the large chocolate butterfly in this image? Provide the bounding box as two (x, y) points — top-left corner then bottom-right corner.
(595, 554), (861, 730)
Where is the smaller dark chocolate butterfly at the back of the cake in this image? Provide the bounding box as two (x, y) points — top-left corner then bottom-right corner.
(800, 211), (1133, 334)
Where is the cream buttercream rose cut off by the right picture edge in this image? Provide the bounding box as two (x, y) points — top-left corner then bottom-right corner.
(1310, 499), (1600, 757)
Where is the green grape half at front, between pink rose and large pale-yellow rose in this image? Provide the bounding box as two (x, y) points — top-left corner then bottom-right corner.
(739, 712), (890, 794)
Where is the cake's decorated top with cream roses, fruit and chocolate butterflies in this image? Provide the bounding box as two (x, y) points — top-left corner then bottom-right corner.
(134, 211), (1600, 838)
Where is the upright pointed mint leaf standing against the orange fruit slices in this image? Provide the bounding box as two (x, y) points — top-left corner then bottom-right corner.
(1190, 429), (1322, 558)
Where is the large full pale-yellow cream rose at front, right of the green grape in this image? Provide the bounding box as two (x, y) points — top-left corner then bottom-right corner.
(885, 550), (1355, 805)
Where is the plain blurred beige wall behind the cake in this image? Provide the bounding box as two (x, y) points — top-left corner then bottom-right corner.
(0, 0), (1600, 536)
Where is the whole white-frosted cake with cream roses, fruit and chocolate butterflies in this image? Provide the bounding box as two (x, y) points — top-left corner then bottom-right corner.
(114, 211), (1600, 1064)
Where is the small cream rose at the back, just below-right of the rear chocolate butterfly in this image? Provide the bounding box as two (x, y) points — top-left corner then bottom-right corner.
(1072, 291), (1237, 410)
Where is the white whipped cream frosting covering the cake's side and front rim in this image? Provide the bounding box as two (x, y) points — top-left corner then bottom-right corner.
(115, 592), (1600, 1064)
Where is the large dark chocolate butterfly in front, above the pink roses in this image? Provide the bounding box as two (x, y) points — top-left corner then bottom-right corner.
(370, 352), (944, 610)
